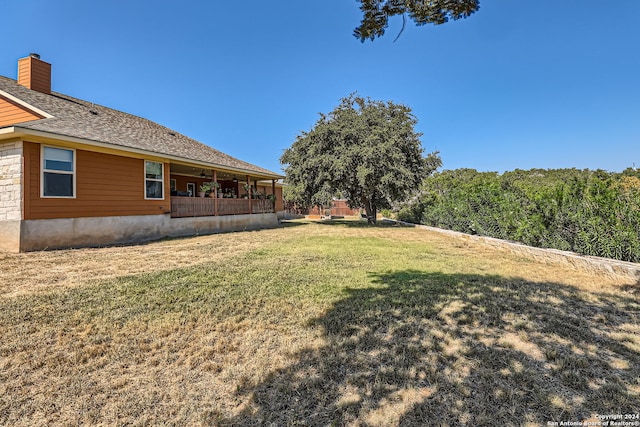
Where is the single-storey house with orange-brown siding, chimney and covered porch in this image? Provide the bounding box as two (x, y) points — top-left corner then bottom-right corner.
(0, 54), (283, 252)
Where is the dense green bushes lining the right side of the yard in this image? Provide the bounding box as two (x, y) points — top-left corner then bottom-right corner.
(398, 168), (640, 262)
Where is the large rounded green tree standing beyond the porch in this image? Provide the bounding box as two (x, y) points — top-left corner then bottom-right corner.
(280, 94), (441, 222)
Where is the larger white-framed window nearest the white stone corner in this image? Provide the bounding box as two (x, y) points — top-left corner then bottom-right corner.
(42, 146), (75, 197)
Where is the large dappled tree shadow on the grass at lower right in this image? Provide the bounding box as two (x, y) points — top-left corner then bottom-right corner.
(222, 271), (640, 426)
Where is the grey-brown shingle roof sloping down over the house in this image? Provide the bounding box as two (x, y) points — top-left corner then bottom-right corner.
(0, 76), (281, 178)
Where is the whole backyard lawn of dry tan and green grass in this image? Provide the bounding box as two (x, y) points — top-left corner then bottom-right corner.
(0, 221), (640, 426)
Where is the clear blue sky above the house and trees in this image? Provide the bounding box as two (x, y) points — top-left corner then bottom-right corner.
(0, 0), (640, 172)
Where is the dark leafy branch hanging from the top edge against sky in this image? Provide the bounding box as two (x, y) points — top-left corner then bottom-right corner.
(353, 0), (480, 42)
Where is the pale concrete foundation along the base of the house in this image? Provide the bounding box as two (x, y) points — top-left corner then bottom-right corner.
(13, 213), (278, 252)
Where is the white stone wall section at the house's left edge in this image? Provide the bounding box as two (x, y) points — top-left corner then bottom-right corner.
(0, 141), (22, 221)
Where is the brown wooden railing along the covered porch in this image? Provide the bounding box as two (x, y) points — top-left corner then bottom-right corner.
(171, 196), (275, 218)
